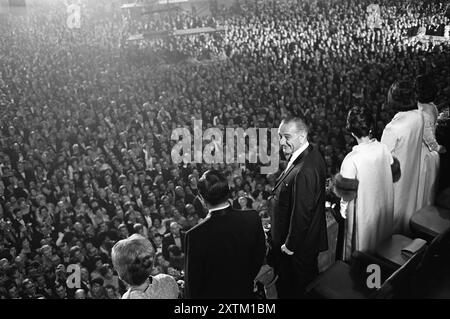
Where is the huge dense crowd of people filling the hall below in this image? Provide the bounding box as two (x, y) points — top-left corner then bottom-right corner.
(0, 0), (450, 299)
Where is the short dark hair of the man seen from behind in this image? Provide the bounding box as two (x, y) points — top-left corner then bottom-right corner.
(198, 170), (230, 205)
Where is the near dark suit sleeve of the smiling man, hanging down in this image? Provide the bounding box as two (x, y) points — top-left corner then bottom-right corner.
(285, 169), (318, 253)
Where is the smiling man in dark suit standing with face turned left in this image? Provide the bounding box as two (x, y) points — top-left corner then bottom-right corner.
(270, 118), (328, 298)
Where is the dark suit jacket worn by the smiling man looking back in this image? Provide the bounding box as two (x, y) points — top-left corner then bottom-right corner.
(271, 145), (328, 292)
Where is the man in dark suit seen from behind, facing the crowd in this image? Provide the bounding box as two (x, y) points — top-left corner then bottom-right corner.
(185, 171), (266, 299)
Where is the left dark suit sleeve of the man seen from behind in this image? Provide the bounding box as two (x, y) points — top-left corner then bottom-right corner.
(184, 232), (206, 299)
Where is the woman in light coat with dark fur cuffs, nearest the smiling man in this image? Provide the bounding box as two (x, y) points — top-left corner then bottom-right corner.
(334, 107), (400, 260)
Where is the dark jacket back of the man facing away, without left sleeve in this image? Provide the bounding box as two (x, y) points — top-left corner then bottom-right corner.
(188, 208), (262, 299)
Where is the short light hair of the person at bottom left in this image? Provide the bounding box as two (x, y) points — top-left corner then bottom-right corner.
(111, 234), (154, 285)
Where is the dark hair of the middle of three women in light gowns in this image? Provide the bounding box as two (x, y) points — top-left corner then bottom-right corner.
(387, 80), (417, 112)
